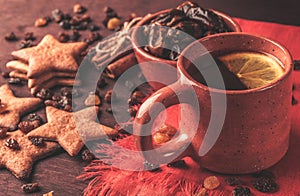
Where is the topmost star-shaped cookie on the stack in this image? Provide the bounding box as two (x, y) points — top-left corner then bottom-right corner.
(12, 34), (87, 78)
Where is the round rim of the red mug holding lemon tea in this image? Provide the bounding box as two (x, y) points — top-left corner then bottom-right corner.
(177, 32), (293, 94)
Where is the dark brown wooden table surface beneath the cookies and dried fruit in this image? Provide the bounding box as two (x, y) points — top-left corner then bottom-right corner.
(0, 0), (300, 196)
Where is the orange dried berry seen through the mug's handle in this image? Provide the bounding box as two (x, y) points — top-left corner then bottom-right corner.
(153, 125), (177, 144)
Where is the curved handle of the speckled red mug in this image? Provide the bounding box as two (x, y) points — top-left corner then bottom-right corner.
(133, 80), (199, 164)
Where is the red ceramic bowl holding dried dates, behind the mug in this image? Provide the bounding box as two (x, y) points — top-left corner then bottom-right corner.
(131, 9), (241, 90)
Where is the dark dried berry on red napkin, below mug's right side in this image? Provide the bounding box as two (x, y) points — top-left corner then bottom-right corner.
(252, 177), (278, 193)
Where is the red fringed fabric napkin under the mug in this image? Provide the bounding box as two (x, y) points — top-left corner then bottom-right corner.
(80, 18), (300, 195)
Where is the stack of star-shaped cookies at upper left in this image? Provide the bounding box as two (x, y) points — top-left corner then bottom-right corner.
(6, 35), (87, 94)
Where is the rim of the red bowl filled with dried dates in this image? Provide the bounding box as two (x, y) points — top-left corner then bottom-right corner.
(131, 8), (242, 67)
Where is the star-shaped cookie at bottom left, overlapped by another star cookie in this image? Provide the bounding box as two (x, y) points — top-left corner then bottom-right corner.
(0, 130), (60, 179)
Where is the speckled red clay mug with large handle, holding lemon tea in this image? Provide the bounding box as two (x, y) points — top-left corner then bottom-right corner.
(134, 33), (292, 174)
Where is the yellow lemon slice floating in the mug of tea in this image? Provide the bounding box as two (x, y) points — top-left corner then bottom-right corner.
(219, 52), (284, 89)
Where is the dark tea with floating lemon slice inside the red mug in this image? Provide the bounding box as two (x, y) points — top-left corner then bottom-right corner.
(188, 52), (284, 90)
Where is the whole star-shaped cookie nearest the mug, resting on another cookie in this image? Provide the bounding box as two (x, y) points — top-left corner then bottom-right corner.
(28, 106), (116, 156)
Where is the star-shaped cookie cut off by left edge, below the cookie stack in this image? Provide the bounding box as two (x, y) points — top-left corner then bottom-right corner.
(0, 84), (42, 129)
